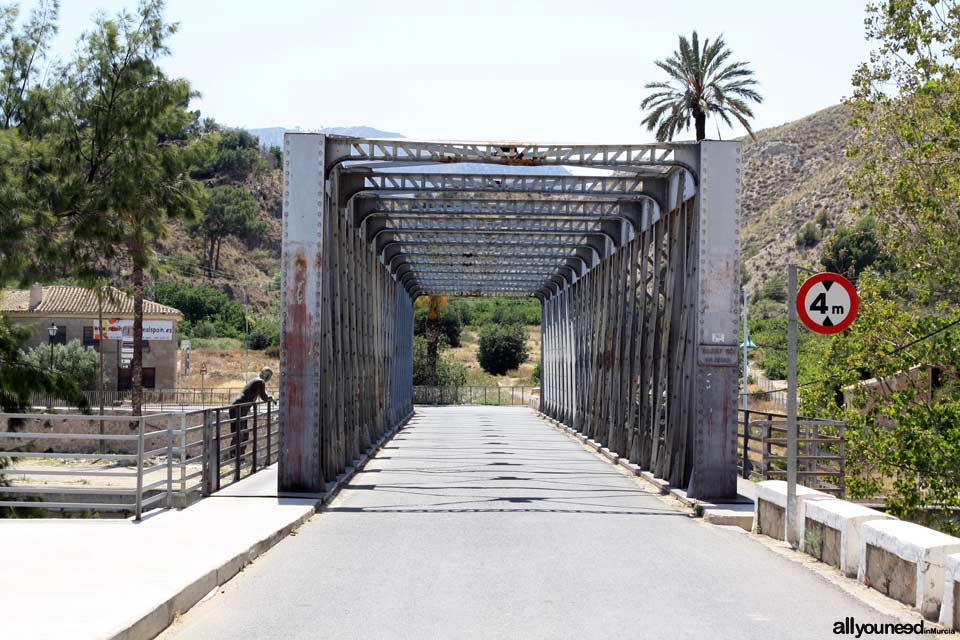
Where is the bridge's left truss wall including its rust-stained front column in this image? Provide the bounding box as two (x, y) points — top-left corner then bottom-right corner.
(279, 135), (413, 493)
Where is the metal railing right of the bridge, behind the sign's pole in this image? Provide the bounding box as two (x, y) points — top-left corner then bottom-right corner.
(737, 409), (846, 497)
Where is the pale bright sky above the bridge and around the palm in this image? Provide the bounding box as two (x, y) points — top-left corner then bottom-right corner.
(43, 0), (869, 143)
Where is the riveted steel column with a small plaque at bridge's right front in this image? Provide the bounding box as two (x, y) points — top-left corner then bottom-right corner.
(684, 141), (741, 499)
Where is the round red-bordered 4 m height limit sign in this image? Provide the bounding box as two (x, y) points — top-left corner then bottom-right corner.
(797, 272), (860, 335)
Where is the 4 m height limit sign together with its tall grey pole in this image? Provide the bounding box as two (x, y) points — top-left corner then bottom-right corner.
(787, 264), (860, 545)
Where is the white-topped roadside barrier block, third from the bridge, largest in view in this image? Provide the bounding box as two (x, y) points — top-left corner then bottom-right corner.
(857, 520), (960, 620)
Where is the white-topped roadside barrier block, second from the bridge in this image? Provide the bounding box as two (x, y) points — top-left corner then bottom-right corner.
(800, 500), (895, 578)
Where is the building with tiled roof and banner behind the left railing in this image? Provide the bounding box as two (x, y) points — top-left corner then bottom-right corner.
(0, 284), (183, 391)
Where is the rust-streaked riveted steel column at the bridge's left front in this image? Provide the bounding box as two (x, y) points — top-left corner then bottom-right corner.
(279, 134), (329, 492)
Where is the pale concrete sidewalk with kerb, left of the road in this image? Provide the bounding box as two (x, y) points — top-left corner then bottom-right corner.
(0, 465), (323, 640)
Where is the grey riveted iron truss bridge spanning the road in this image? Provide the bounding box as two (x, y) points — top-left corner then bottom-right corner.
(280, 134), (741, 499)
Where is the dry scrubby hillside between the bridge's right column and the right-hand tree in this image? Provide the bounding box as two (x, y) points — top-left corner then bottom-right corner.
(740, 105), (858, 293)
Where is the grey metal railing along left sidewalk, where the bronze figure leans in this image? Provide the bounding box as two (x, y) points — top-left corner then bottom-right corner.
(0, 402), (280, 519)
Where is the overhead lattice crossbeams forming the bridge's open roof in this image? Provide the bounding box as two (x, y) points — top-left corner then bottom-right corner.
(324, 136), (697, 297)
